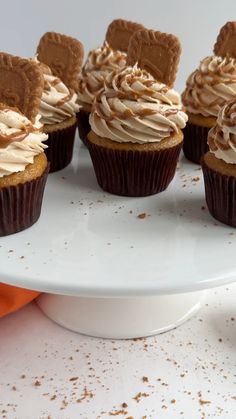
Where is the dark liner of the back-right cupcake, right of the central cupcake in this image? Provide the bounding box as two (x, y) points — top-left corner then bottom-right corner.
(183, 122), (210, 164)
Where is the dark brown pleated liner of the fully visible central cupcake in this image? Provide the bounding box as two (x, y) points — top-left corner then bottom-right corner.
(87, 140), (182, 196)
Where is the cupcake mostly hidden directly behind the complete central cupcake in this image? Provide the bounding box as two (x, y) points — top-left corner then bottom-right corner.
(77, 19), (143, 142)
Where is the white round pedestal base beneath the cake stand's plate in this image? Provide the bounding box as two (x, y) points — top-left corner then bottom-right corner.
(37, 291), (206, 339)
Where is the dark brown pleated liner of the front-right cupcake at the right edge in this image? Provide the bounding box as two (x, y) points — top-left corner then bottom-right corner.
(201, 159), (236, 227)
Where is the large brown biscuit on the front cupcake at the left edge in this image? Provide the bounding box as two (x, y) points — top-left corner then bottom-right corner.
(0, 52), (44, 122)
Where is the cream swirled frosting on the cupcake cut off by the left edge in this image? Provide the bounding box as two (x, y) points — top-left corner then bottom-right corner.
(0, 105), (48, 177)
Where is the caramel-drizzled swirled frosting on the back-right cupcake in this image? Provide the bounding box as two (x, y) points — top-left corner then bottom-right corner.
(182, 56), (236, 117)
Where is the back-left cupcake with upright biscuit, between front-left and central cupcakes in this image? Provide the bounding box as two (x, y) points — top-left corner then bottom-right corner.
(37, 32), (83, 172)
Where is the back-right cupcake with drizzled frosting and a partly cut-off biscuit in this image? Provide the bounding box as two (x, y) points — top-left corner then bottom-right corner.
(182, 22), (236, 163)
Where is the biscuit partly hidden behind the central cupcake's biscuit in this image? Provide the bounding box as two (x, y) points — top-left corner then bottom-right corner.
(106, 19), (144, 52)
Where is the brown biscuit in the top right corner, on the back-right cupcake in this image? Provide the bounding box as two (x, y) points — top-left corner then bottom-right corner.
(213, 22), (236, 58)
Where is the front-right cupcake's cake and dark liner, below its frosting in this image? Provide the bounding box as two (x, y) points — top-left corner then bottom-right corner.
(201, 152), (236, 227)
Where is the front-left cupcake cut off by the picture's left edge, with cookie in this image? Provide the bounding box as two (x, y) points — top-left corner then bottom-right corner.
(0, 53), (49, 236)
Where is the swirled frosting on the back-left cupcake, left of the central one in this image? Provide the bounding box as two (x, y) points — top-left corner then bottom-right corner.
(32, 57), (80, 125)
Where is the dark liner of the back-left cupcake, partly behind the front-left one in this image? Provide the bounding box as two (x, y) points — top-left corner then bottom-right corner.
(44, 123), (76, 173)
